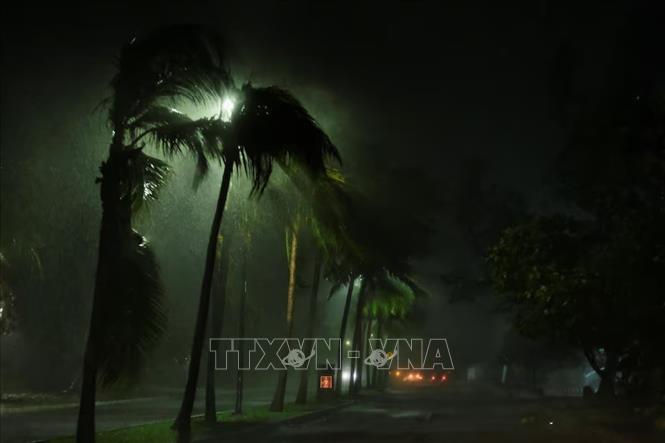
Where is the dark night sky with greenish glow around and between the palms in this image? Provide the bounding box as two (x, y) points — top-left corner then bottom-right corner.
(0, 0), (657, 388)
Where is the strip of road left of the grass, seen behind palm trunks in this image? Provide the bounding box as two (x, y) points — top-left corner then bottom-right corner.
(0, 389), (272, 443)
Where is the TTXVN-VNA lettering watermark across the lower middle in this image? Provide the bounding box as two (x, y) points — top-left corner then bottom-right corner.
(210, 338), (455, 371)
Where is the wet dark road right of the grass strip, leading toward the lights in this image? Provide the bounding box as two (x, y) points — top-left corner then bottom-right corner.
(223, 383), (652, 443)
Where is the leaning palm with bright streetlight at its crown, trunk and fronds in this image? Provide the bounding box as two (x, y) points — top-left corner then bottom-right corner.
(173, 83), (339, 439)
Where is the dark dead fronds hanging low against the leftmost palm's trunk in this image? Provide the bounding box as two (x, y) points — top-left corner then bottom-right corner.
(95, 232), (166, 386)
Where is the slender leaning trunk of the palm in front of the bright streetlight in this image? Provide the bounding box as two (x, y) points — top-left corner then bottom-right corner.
(172, 164), (233, 442)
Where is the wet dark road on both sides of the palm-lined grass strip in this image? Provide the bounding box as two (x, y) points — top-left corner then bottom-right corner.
(0, 383), (665, 443)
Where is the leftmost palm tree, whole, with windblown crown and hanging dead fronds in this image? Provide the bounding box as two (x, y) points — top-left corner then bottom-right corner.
(77, 26), (224, 442)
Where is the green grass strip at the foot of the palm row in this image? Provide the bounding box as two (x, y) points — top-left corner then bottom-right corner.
(48, 403), (330, 443)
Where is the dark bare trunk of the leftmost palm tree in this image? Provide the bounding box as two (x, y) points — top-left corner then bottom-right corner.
(76, 143), (131, 443)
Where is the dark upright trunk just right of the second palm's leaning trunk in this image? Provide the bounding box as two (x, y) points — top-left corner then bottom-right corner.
(205, 236), (231, 423)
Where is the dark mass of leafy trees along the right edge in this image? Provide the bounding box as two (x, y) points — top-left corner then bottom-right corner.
(488, 21), (665, 386)
